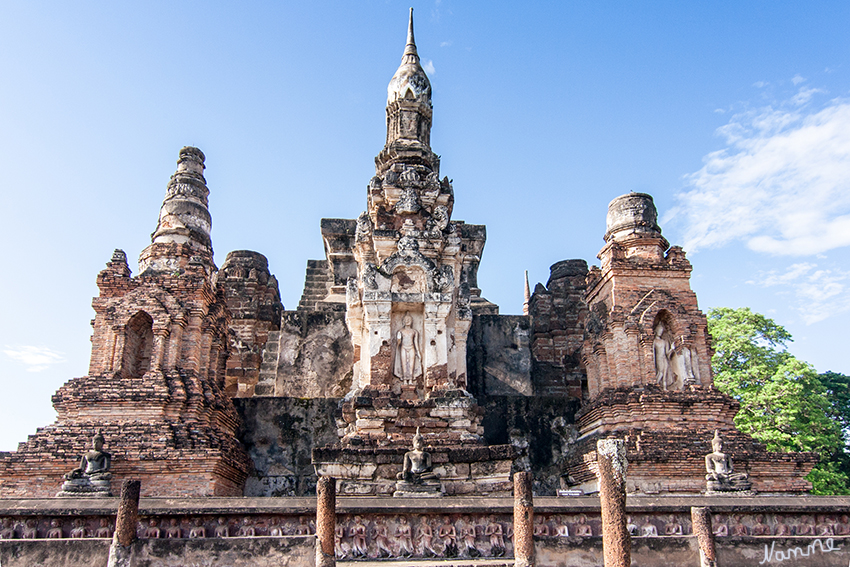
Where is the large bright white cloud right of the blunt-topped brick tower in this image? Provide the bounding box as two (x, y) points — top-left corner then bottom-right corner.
(665, 87), (850, 256)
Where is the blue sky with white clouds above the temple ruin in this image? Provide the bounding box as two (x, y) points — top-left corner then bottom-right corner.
(0, 0), (850, 450)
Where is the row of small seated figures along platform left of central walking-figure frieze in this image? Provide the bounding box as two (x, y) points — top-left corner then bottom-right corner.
(0, 516), (315, 539)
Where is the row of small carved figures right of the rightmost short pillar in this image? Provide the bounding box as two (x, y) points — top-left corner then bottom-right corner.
(712, 514), (850, 537)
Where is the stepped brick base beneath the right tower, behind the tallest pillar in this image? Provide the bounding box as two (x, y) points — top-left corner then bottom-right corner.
(561, 385), (817, 495)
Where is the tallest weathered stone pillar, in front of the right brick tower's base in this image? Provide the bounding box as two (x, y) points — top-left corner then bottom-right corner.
(596, 439), (632, 567)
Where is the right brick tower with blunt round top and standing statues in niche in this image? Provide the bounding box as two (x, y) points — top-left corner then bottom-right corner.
(564, 193), (815, 493)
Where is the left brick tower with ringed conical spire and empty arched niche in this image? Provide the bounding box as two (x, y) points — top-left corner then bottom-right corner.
(0, 147), (250, 497)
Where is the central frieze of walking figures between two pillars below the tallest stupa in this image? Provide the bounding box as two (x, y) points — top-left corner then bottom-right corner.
(335, 515), (513, 559)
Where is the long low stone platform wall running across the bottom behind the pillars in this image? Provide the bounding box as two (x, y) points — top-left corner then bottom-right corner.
(0, 496), (850, 567)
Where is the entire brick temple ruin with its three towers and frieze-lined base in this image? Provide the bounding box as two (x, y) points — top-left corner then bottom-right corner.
(0, 8), (850, 565)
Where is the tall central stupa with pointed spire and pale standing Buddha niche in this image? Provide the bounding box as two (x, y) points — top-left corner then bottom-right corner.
(313, 9), (511, 494)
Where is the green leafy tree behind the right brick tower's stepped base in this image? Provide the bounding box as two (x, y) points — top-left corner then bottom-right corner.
(708, 307), (850, 494)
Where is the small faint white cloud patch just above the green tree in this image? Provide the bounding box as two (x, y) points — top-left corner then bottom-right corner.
(747, 262), (850, 325)
